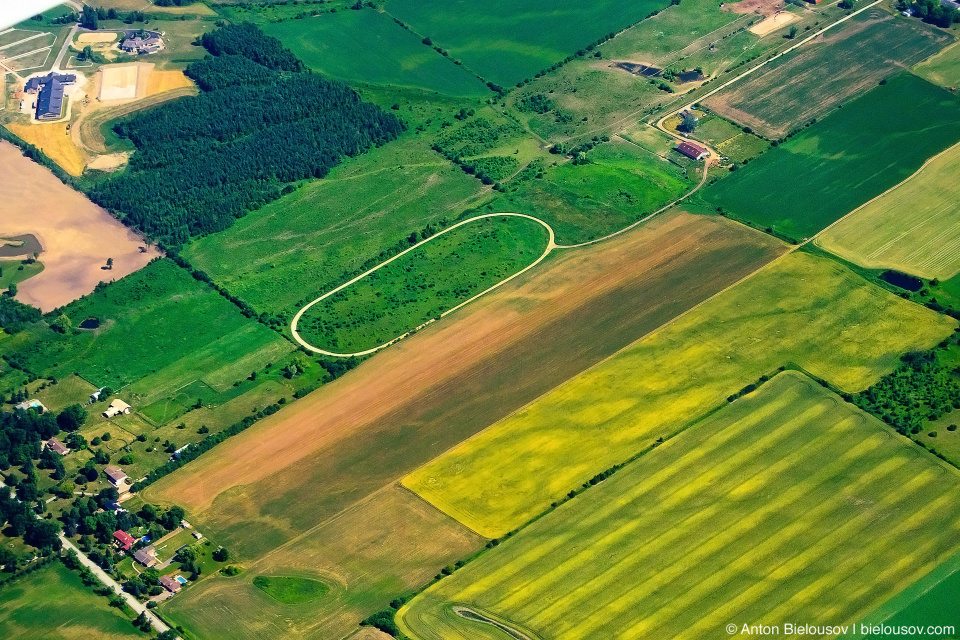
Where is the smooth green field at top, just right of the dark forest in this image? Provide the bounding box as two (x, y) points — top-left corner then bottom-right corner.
(263, 8), (490, 96)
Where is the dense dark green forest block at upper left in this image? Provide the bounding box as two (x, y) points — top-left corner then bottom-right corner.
(89, 24), (404, 247)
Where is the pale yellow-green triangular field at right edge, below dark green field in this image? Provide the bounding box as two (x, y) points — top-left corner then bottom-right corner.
(816, 141), (960, 280)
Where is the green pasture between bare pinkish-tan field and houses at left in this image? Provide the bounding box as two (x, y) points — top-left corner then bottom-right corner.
(4, 260), (293, 404)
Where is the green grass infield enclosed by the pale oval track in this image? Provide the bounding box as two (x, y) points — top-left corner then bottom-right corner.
(297, 217), (549, 353)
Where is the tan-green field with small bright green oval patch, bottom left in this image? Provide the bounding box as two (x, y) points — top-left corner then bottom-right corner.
(163, 486), (486, 640)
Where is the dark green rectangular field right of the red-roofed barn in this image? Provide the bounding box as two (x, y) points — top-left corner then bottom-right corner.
(703, 74), (960, 239)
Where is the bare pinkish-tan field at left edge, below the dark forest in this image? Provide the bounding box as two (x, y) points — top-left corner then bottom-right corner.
(0, 141), (159, 311)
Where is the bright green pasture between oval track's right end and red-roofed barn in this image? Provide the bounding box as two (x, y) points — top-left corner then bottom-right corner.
(492, 139), (693, 244)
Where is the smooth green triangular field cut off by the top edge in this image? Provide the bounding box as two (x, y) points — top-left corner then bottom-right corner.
(386, 0), (666, 87)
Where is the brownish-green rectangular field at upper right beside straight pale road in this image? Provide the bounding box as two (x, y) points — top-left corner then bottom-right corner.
(706, 8), (951, 139)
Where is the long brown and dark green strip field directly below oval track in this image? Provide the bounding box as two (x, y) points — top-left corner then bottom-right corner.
(147, 213), (785, 557)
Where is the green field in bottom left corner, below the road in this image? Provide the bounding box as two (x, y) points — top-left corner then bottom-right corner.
(0, 562), (149, 640)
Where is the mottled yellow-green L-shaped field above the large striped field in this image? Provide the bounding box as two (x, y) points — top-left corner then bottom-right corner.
(403, 253), (957, 537)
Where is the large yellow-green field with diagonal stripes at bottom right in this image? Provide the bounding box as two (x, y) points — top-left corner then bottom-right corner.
(398, 372), (960, 640)
